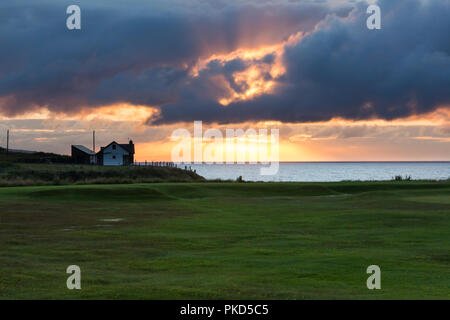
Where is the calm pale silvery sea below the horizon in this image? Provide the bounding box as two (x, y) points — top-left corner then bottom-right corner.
(183, 162), (450, 182)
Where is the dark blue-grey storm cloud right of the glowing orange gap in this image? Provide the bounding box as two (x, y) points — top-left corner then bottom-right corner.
(154, 0), (450, 123)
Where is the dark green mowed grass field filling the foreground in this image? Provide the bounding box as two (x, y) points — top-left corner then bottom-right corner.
(0, 182), (450, 299)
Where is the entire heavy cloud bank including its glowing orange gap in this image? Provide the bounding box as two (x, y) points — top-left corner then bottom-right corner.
(0, 0), (450, 124)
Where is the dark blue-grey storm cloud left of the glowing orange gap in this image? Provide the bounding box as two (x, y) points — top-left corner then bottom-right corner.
(0, 0), (338, 115)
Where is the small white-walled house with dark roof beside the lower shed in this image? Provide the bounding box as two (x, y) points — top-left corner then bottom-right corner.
(97, 140), (134, 166)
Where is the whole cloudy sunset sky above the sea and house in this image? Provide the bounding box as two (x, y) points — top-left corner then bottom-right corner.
(0, 0), (450, 161)
